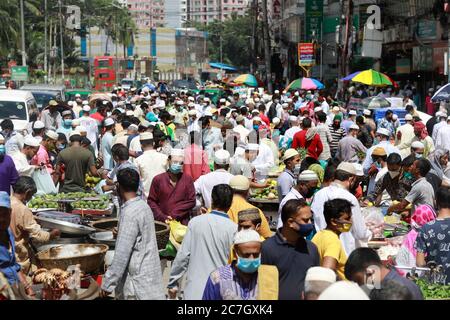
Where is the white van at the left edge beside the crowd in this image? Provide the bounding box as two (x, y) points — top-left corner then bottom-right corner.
(0, 90), (39, 132)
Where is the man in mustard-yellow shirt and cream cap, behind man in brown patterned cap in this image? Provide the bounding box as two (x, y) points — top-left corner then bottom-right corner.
(228, 175), (272, 238)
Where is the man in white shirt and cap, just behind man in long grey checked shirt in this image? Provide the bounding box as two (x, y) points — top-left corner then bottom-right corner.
(134, 132), (167, 199)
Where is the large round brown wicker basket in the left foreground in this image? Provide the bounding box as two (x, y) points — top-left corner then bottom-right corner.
(36, 244), (109, 273)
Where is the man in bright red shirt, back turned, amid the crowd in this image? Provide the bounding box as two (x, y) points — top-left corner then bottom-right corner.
(292, 118), (323, 160)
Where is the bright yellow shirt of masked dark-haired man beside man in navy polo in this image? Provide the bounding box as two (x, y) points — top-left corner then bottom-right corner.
(312, 230), (347, 280)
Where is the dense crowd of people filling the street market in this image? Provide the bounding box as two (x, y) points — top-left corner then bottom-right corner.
(0, 83), (450, 300)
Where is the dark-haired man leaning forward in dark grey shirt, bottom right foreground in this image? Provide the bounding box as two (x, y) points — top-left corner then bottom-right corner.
(345, 248), (423, 300)
